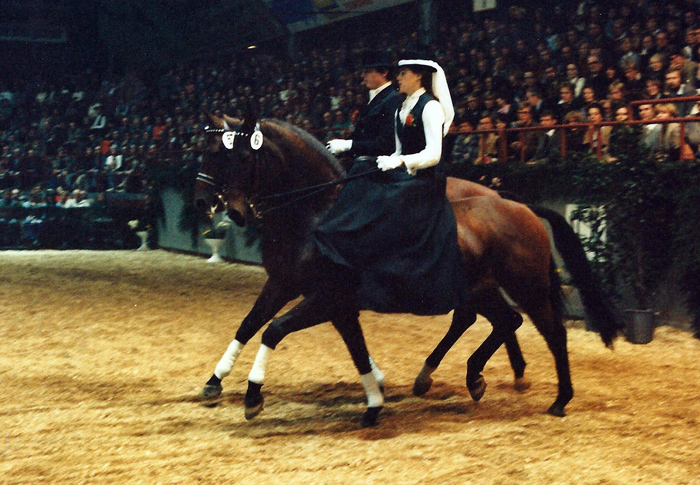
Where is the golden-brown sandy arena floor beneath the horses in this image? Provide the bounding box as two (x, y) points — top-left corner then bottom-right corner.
(0, 251), (700, 485)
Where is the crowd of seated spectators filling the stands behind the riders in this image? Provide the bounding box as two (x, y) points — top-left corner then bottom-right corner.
(0, 0), (700, 211)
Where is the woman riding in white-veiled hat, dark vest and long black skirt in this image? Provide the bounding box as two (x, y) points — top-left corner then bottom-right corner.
(312, 55), (467, 315)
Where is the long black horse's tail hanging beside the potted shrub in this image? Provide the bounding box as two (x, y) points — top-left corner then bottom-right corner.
(528, 205), (624, 347)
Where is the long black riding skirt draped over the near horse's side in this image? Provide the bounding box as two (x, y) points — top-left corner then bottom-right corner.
(311, 161), (468, 315)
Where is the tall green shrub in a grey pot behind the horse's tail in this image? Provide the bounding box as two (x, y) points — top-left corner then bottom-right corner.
(579, 127), (674, 343)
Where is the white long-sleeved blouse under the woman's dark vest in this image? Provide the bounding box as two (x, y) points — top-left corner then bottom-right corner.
(394, 88), (445, 175)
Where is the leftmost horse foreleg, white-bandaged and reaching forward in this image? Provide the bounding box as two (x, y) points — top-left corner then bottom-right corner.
(199, 278), (298, 400)
